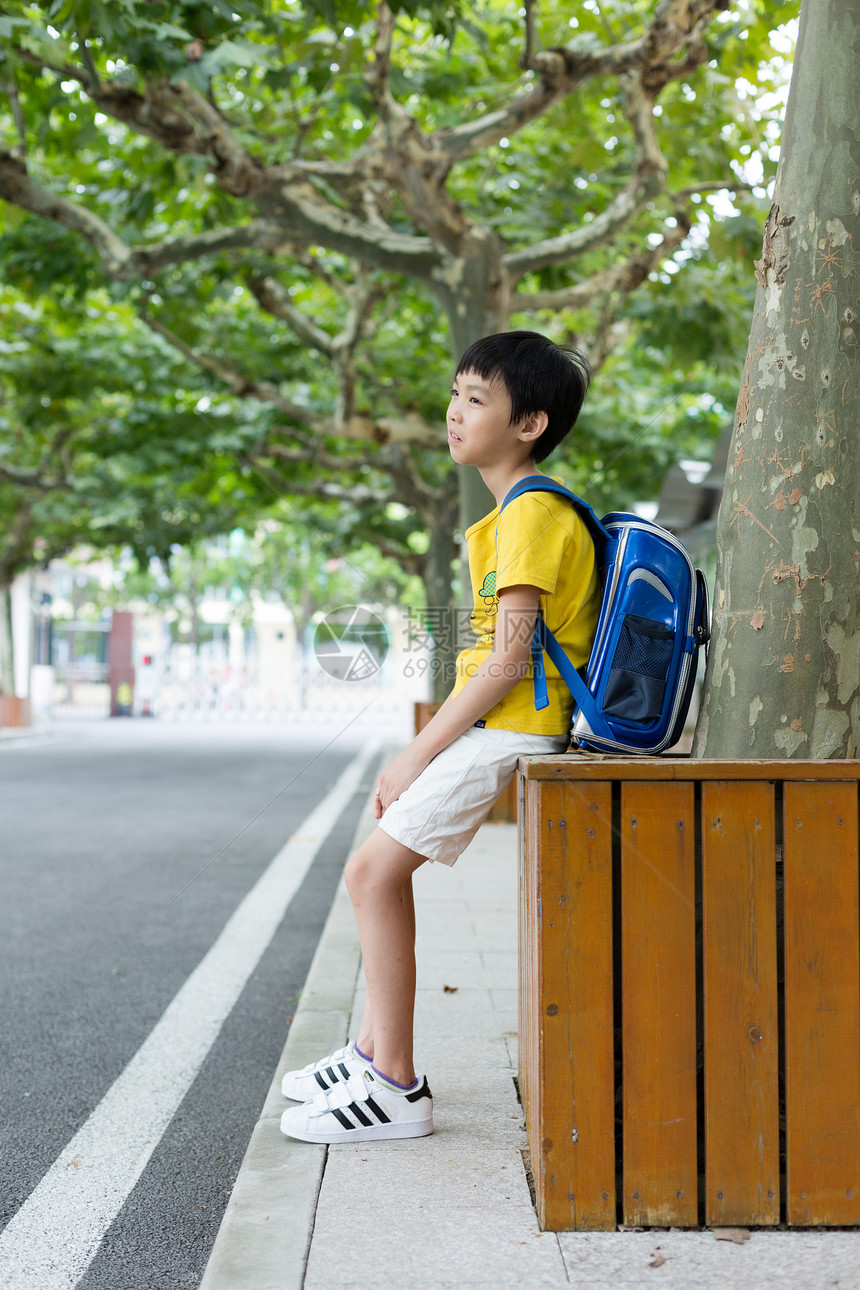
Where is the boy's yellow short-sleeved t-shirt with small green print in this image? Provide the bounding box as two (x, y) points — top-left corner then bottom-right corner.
(454, 476), (601, 734)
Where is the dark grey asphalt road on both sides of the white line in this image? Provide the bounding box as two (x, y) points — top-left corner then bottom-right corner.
(0, 721), (384, 1290)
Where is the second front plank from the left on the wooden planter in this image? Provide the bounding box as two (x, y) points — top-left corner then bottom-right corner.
(621, 782), (698, 1227)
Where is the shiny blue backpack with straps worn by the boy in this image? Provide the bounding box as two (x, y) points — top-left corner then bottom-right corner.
(499, 475), (710, 755)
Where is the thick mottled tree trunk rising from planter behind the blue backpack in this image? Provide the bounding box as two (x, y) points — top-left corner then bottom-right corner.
(695, 0), (860, 759)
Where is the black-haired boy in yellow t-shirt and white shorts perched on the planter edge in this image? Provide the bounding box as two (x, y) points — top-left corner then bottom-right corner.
(281, 332), (600, 1143)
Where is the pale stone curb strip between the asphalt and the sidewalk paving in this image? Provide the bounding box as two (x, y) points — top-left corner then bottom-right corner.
(200, 774), (387, 1290)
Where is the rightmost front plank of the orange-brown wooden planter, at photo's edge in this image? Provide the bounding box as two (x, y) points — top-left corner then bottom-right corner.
(784, 783), (860, 1226)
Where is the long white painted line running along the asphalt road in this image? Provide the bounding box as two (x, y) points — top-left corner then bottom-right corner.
(0, 743), (379, 1290)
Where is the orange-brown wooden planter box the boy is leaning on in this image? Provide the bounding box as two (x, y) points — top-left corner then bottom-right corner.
(518, 755), (860, 1231)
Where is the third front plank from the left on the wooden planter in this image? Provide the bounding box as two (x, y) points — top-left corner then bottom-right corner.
(701, 782), (780, 1227)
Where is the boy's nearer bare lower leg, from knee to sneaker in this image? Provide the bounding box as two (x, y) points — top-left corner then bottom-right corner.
(346, 828), (425, 1085)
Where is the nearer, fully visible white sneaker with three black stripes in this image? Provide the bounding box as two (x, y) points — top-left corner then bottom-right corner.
(281, 1069), (433, 1143)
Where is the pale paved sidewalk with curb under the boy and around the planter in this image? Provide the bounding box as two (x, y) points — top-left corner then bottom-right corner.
(201, 789), (860, 1290)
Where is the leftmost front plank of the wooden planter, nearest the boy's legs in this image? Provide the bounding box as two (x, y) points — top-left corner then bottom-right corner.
(523, 783), (616, 1231)
